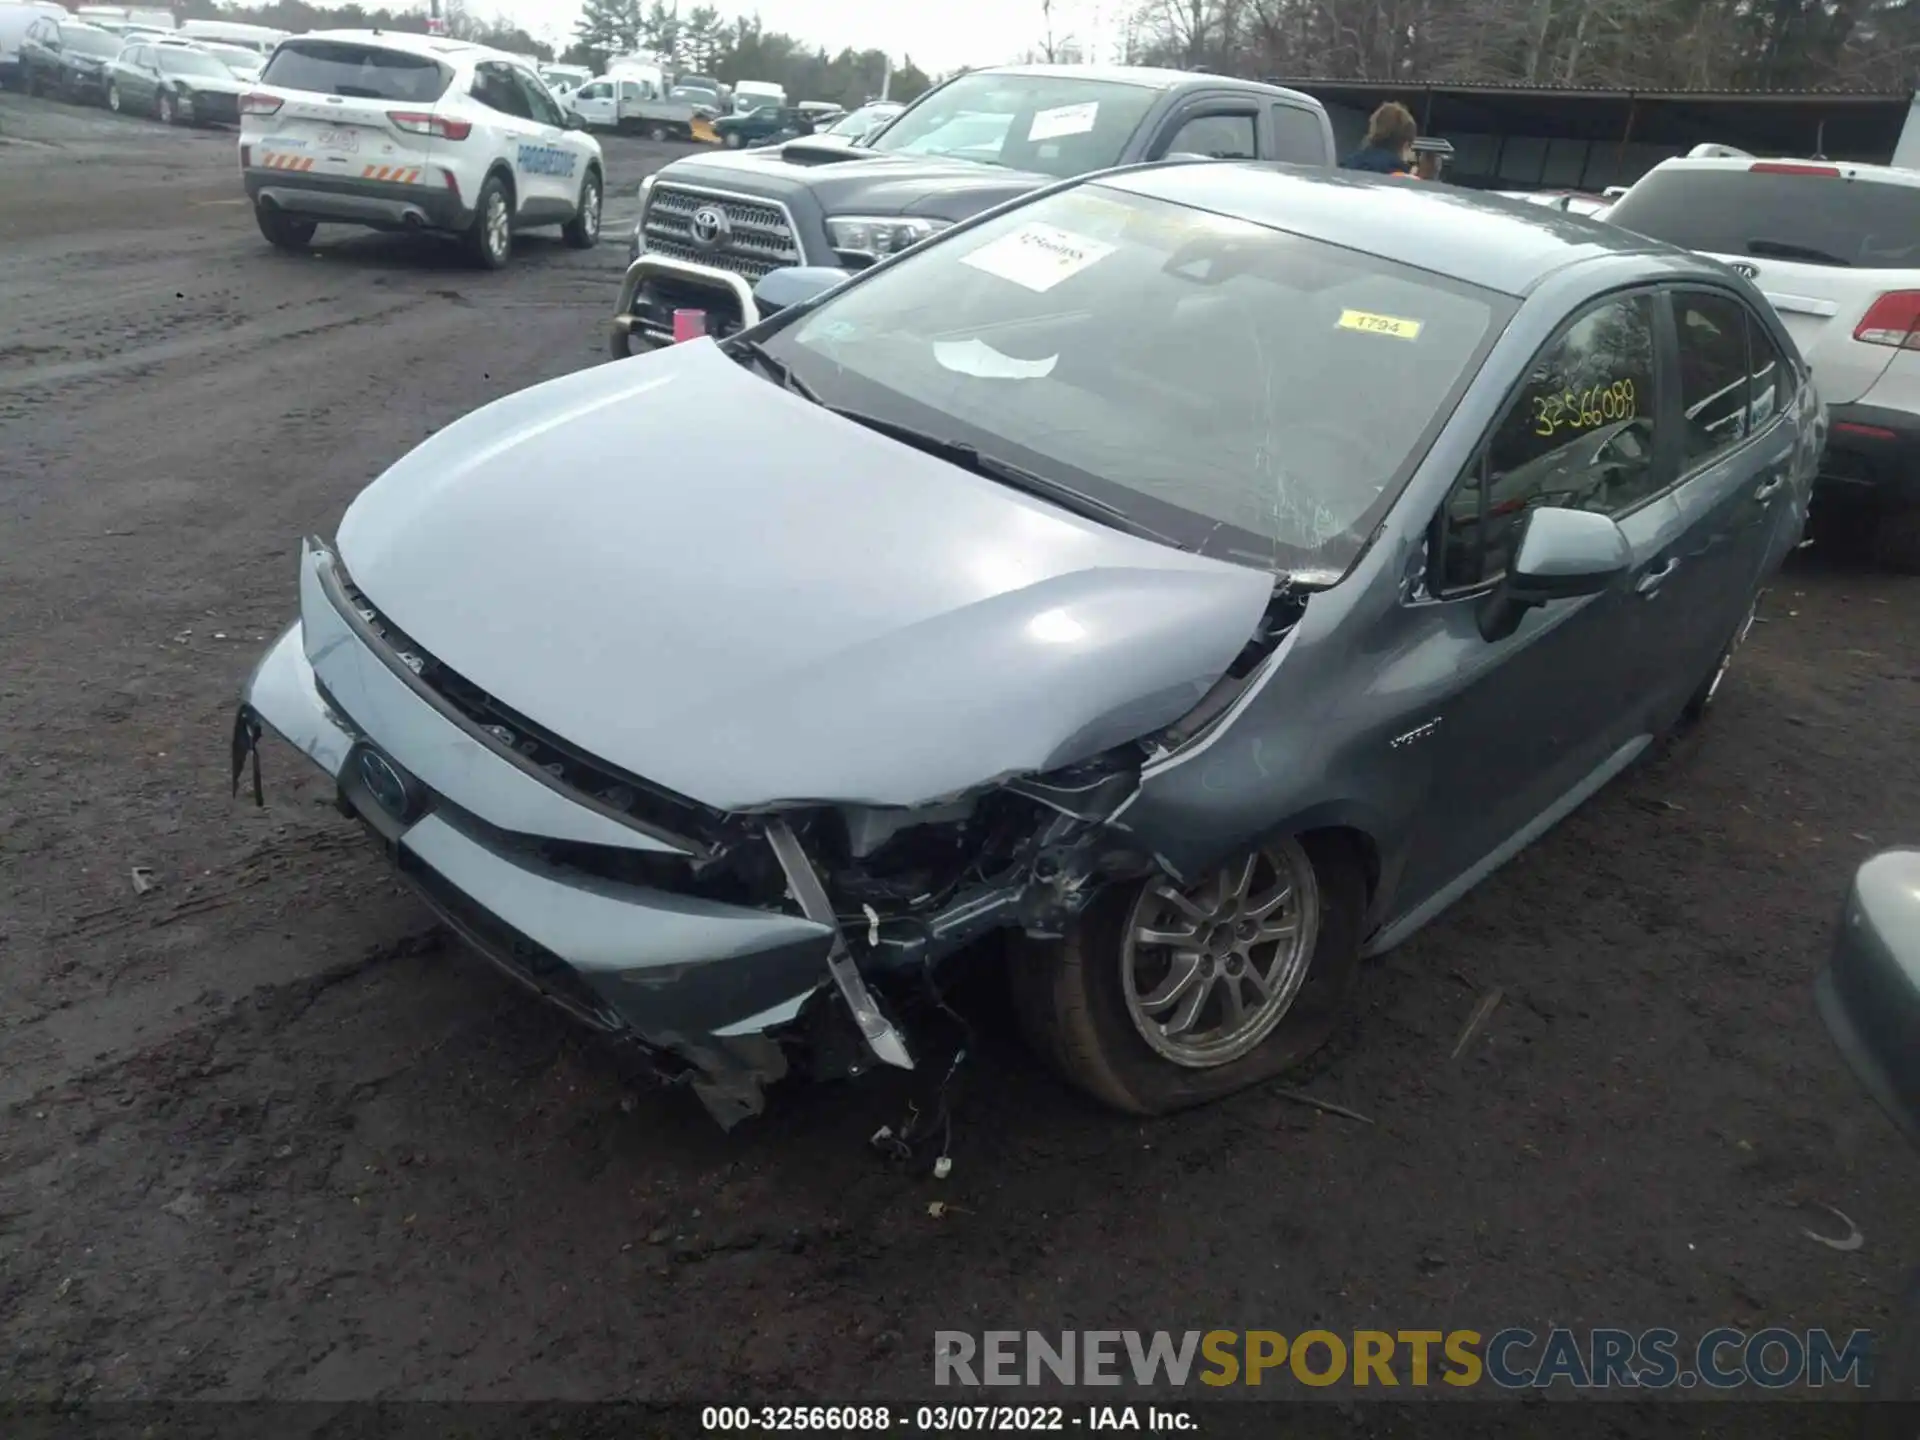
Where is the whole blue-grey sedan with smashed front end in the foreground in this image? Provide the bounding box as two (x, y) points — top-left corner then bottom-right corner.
(234, 161), (1826, 1123)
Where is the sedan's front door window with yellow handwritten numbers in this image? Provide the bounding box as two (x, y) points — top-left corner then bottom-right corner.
(1438, 294), (1668, 593)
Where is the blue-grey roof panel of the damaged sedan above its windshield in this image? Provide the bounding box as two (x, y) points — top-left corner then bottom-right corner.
(1087, 159), (1697, 296)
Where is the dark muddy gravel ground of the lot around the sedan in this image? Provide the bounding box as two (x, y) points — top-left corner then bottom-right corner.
(0, 98), (1920, 1400)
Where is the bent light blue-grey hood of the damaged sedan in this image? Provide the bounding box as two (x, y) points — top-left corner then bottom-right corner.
(338, 340), (1273, 810)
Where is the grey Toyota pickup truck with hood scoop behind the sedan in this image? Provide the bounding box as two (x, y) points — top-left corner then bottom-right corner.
(611, 65), (1334, 357)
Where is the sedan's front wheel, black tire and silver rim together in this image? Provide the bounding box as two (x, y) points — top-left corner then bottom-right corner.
(1010, 835), (1367, 1116)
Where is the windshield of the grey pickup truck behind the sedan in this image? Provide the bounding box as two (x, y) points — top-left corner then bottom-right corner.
(872, 71), (1160, 180)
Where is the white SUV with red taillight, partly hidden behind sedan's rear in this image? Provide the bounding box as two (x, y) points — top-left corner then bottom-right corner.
(1607, 156), (1920, 570)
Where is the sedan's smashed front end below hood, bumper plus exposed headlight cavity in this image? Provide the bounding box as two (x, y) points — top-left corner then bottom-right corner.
(236, 541), (1244, 1123)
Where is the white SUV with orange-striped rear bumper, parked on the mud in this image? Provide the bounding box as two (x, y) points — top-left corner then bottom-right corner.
(240, 31), (607, 269)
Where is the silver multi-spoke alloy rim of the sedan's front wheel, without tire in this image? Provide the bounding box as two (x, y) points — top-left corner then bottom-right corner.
(1121, 839), (1321, 1069)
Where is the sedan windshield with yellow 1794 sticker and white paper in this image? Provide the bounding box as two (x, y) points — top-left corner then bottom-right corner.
(762, 184), (1511, 582)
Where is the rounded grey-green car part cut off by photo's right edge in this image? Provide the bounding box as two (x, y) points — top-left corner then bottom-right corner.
(1814, 851), (1920, 1144)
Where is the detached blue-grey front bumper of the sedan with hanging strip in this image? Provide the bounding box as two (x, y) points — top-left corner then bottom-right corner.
(232, 540), (914, 1125)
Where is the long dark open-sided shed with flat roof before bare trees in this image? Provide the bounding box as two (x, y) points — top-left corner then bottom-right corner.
(1275, 77), (1920, 190)
